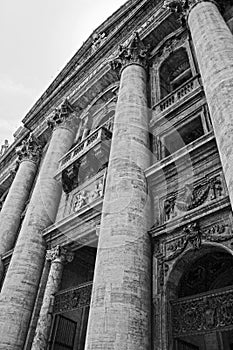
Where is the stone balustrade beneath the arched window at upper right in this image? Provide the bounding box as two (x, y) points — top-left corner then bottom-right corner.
(153, 75), (202, 116)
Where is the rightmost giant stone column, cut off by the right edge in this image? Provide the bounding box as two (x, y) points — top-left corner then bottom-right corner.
(165, 0), (233, 206)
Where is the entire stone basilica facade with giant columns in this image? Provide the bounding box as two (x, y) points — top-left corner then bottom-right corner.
(0, 0), (233, 350)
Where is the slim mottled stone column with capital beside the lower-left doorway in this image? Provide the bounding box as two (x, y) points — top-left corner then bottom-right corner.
(31, 246), (73, 350)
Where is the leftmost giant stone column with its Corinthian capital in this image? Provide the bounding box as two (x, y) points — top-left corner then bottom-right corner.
(0, 134), (41, 280)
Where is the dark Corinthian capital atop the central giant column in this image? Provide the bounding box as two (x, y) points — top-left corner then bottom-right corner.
(110, 32), (149, 71)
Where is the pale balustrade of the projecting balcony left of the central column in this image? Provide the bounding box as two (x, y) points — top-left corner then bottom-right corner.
(59, 126), (112, 173)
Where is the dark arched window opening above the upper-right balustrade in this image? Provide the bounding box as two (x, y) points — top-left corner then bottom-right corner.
(159, 48), (192, 99)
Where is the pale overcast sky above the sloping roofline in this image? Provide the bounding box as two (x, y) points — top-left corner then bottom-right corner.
(0, 0), (126, 145)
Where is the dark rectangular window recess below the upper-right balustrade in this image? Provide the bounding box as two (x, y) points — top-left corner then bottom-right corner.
(164, 117), (204, 157)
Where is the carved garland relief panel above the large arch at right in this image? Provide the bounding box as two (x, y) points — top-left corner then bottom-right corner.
(163, 175), (225, 221)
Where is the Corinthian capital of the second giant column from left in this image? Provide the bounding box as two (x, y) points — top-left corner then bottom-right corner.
(47, 99), (78, 129)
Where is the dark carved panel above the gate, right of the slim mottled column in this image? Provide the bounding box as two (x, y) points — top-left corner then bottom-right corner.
(53, 283), (92, 314)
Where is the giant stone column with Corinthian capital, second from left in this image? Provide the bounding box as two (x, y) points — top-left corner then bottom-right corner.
(0, 101), (76, 350)
